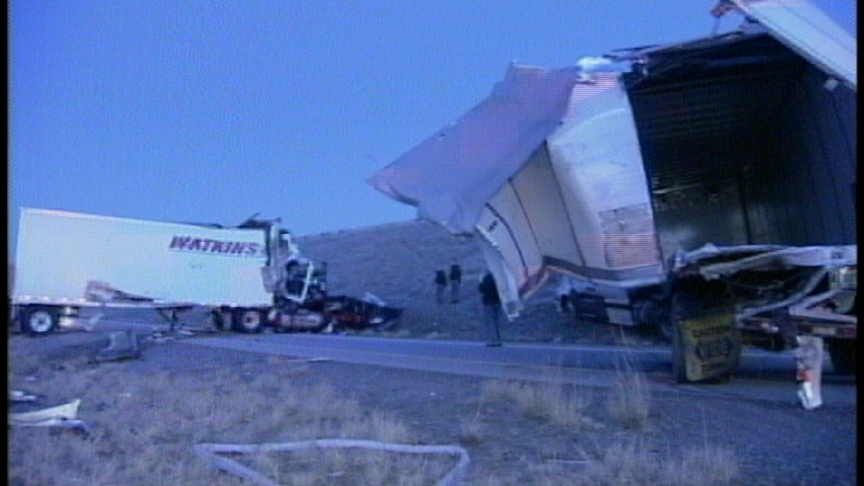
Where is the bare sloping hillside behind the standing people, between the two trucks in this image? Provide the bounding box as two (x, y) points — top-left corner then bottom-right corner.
(297, 220), (648, 343)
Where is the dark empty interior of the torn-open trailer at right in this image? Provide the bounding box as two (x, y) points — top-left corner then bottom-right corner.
(624, 28), (857, 260)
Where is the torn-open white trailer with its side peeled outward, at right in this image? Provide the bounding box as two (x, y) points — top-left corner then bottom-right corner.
(367, 0), (857, 381)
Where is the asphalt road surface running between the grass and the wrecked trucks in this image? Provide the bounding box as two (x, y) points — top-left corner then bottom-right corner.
(184, 334), (857, 404)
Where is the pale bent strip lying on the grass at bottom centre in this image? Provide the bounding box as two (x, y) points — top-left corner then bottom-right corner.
(194, 439), (471, 486)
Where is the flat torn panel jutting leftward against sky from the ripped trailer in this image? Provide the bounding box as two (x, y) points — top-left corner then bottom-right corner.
(367, 65), (581, 234)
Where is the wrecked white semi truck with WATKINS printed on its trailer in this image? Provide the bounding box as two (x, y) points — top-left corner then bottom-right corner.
(11, 208), (401, 335)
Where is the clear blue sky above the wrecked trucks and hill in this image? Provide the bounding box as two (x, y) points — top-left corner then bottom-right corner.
(7, 0), (857, 258)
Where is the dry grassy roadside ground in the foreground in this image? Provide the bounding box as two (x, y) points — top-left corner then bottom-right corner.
(9, 336), (740, 486)
